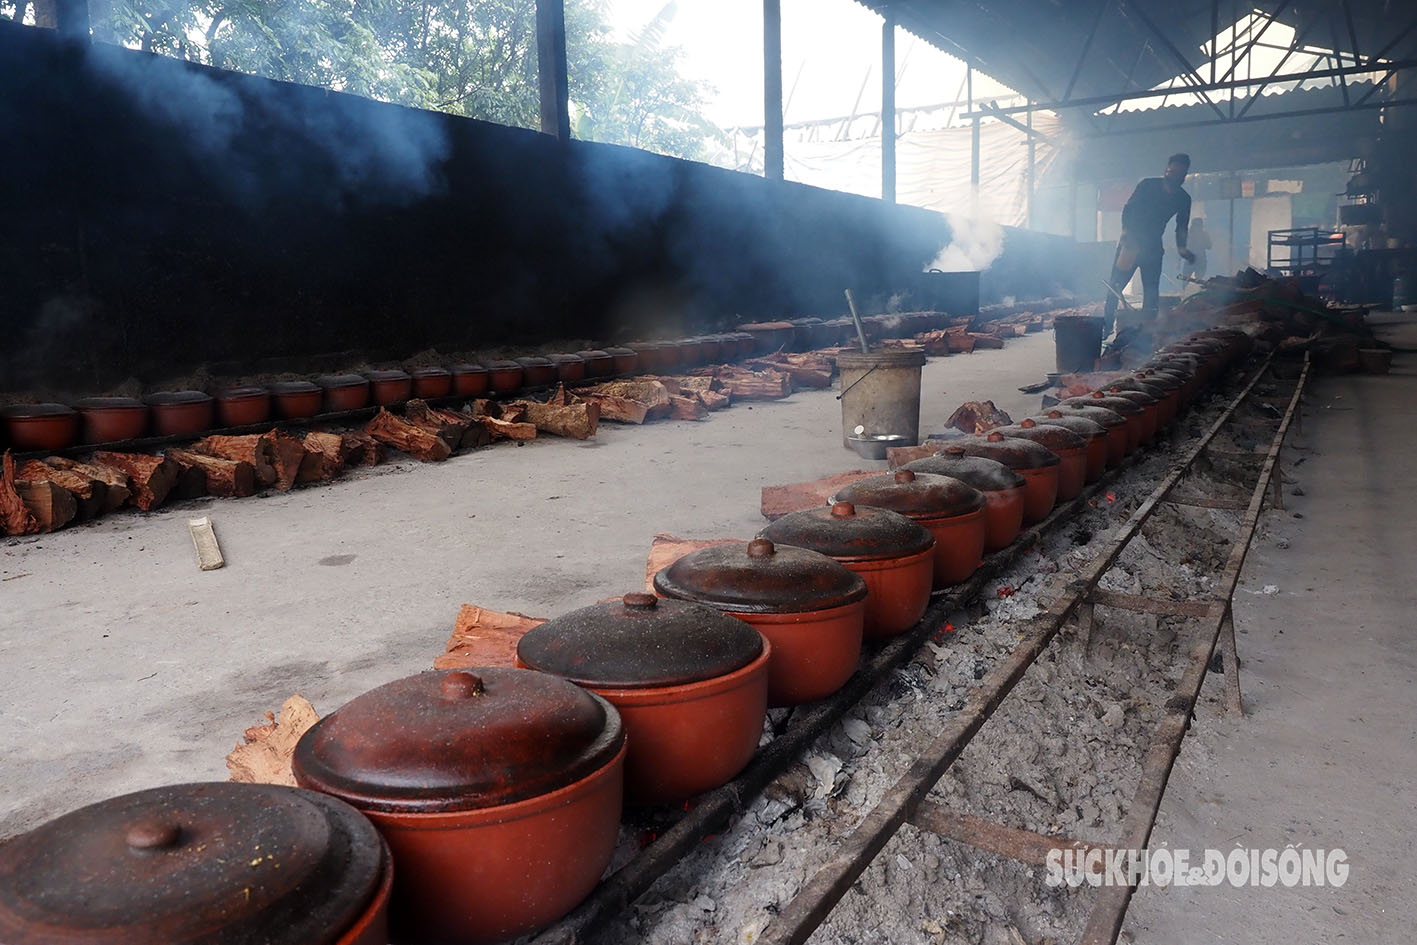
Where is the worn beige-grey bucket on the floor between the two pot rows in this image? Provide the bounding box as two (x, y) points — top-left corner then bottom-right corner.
(836, 347), (925, 449)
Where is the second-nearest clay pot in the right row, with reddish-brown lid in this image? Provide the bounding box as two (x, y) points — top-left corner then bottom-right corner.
(292, 667), (625, 945)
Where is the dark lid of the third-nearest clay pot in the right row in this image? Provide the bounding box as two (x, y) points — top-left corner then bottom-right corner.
(517, 592), (762, 689)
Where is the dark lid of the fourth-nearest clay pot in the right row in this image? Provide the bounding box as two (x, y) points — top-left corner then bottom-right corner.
(655, 538), (866, 613)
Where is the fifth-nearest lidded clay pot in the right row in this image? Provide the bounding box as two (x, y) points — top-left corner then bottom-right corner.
(760, 502), (935, 639)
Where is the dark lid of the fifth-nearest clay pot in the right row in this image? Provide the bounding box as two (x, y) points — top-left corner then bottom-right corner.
(761, 502), (935, 561)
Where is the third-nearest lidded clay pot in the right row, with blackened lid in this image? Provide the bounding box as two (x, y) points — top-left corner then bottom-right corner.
(517, 592), (771, 803)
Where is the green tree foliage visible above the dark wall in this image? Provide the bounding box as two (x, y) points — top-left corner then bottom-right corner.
(82, 0), (720, 159)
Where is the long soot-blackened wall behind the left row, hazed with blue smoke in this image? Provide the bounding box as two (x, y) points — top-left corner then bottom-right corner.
(0, 23), (1067, 391)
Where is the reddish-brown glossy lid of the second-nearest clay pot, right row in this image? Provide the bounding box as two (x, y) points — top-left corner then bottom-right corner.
(293, 666), (625, 813)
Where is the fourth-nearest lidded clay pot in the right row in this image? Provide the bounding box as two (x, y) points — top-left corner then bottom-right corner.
(655, 538), (866, 706)
